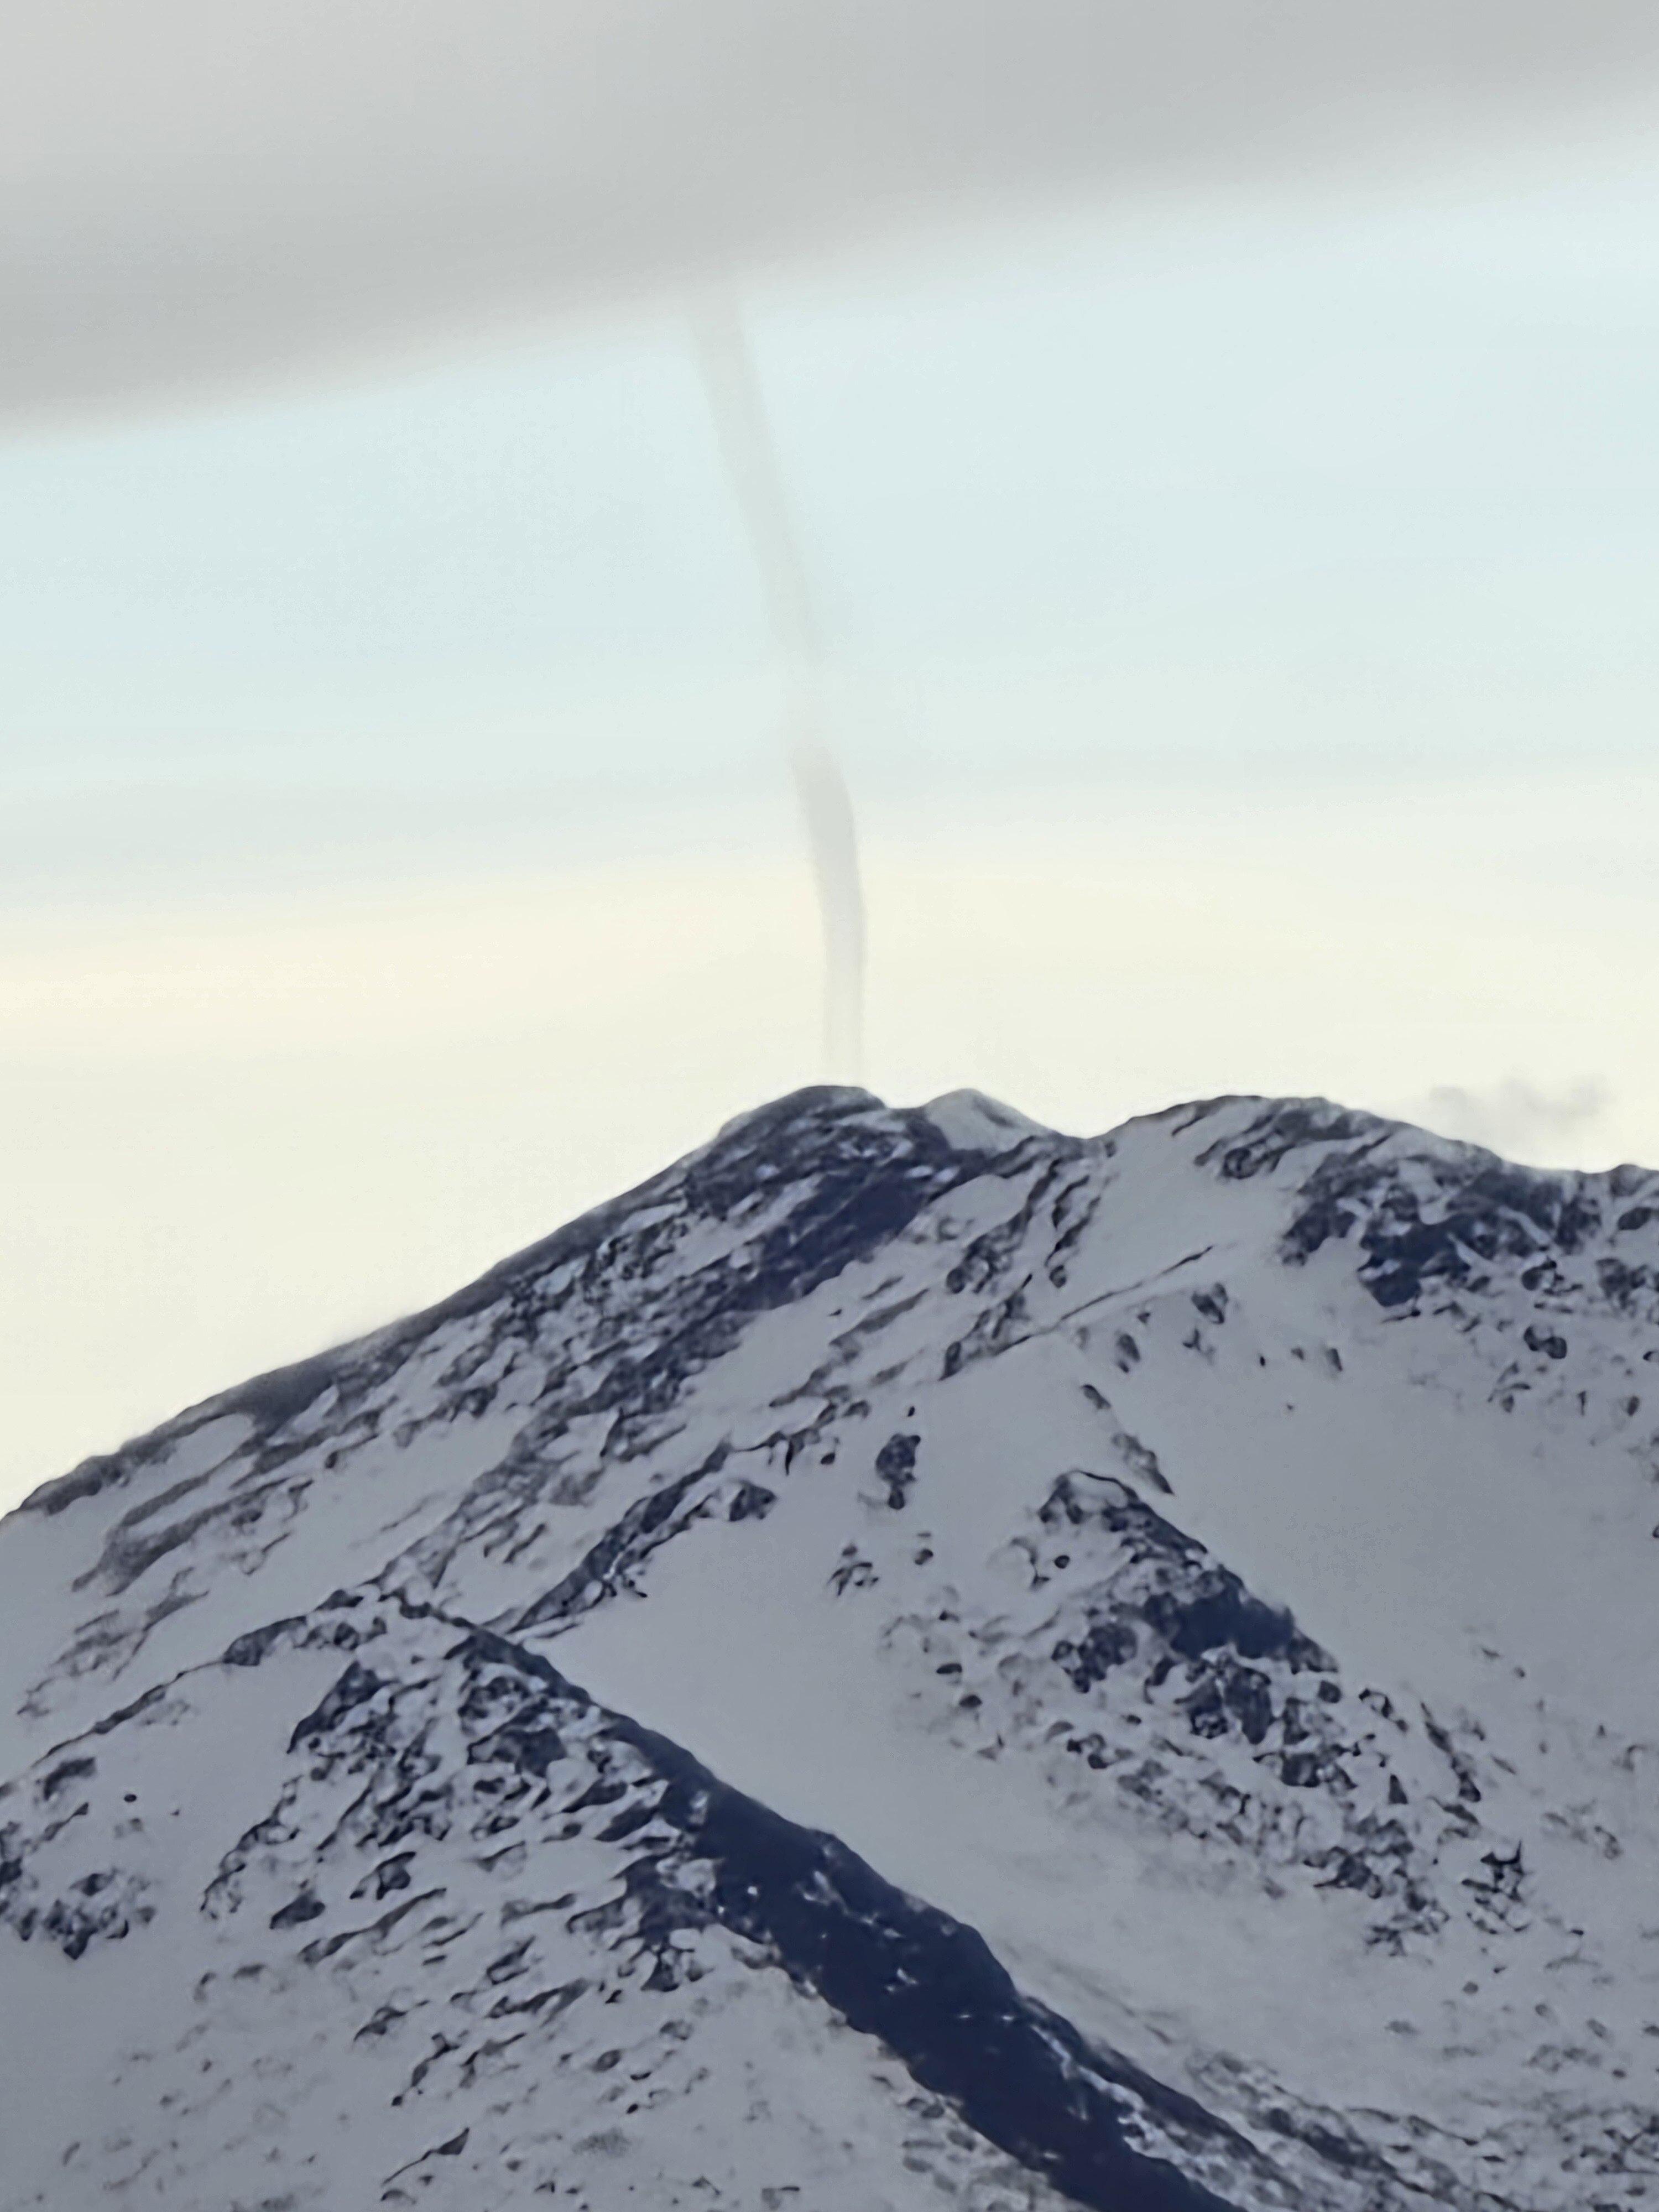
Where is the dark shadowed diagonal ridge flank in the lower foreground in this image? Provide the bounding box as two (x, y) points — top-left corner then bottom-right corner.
(460, 1630), (1254, 2212)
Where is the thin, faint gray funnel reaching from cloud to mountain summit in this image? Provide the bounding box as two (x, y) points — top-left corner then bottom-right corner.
(695, 303), (865, 1084)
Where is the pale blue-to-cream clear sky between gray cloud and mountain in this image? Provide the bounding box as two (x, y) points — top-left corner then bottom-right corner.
(0, 128), (1659, 1504)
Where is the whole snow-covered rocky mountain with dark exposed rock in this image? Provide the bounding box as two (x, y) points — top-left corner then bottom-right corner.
(0, 1091), (1659, 2212)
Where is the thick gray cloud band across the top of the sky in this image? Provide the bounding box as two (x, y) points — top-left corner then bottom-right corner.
(0, 0), (1659, 414)
